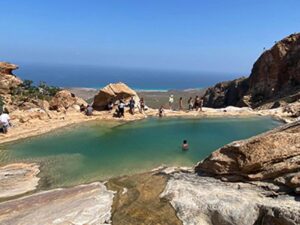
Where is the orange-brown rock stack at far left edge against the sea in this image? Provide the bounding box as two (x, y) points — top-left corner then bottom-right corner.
(0, 62), (22, 96)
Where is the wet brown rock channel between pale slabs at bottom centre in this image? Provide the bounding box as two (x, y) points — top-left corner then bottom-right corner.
(106, 170), (182, 225)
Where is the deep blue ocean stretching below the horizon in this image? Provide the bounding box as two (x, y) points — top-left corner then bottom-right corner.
(14, 64), (237, 90)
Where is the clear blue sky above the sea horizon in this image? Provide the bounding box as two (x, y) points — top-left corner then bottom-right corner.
(0, 0), (300, 74)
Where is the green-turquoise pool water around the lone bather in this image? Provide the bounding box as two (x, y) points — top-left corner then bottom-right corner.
(0, 117), (280, 188)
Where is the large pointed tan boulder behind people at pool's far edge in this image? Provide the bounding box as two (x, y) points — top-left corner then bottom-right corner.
(93, 83), (139, 110)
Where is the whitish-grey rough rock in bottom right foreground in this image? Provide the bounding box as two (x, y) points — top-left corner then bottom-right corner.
(161, 173), (300, 225)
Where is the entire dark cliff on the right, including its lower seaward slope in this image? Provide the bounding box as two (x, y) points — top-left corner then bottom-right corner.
(204, 33), (300, 108)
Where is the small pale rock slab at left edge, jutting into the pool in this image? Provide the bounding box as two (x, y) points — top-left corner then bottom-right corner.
(0, 163), (40, 198)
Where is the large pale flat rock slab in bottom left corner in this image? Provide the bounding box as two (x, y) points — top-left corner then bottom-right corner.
(0, 183), (113, 225)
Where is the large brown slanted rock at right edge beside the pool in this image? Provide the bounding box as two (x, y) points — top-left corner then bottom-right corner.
(195, 121), (300, 192)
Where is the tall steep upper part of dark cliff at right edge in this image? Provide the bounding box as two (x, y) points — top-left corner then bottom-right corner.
(249, 33), (300, 101)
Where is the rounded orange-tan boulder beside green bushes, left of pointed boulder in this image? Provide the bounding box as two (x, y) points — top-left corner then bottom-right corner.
(49, 90), (87, 112)
